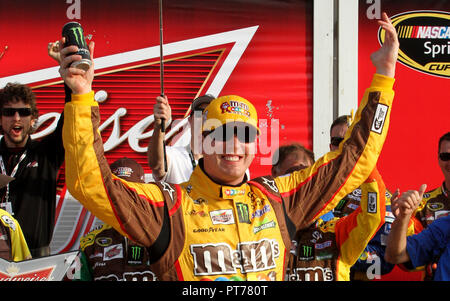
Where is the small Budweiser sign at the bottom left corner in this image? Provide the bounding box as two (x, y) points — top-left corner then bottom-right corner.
(0, 251), (79, 281)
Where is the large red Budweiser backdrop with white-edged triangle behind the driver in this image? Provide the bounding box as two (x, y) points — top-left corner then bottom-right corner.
(0, 0), (312, 252)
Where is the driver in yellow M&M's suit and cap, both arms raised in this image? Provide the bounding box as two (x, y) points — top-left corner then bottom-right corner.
(60, 14), (399, 280)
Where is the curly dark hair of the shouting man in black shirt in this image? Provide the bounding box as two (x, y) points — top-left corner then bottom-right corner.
(0, 83), (39, 119)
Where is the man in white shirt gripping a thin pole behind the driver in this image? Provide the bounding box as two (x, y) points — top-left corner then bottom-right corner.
(147, 95), (214, 184)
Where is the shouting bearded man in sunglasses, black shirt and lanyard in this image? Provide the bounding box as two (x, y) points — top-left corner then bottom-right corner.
(0, 83), (64, 258)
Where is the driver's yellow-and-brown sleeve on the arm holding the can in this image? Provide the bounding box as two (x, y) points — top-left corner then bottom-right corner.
(63, 92), (164, 246)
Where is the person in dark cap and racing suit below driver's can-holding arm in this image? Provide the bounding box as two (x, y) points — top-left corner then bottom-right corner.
(77, 157), (156, 281)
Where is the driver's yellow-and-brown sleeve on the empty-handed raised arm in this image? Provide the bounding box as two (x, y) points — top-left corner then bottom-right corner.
(275, 74), (394, 230)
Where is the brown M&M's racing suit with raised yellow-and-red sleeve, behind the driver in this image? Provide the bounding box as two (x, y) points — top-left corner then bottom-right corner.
(288, 169), (386, 281)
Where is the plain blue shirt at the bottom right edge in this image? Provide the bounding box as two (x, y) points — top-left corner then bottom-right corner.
(406, 216), (450, 281)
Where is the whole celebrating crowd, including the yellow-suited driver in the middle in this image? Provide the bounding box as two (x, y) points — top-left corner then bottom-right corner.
(0, 13), (450, 281)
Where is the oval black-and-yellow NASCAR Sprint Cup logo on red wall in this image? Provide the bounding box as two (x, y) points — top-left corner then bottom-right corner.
(378, 11), (450, 78)
